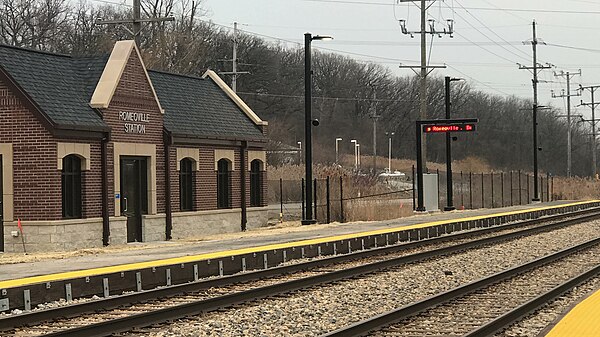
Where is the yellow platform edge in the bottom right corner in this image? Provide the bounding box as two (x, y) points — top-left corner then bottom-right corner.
(546, 284), (600, 337)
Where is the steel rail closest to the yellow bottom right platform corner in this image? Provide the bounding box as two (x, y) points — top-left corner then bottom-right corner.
(463, 265), (600, 337)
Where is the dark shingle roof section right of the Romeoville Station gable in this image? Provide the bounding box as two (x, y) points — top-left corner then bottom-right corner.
(148, 71), (265, 140)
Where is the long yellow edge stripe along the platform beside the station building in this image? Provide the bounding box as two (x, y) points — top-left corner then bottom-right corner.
(0, 200), (600, 289)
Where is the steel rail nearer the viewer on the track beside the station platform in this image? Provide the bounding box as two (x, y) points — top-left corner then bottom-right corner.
(29, 209), (600, 337)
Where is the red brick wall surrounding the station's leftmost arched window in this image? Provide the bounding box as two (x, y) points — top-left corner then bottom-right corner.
(0, 81), (102, 221)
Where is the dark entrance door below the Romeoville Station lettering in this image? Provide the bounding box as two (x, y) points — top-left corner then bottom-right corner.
(121, 157), (148, 242)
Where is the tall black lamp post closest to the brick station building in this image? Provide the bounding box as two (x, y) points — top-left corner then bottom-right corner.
(302, 33), (332, 225)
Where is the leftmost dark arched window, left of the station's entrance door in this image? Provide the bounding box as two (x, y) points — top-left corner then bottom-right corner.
(62, 154), (81, 219)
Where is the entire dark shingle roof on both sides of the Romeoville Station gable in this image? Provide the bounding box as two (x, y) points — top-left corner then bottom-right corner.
(0, 45), (266, 141)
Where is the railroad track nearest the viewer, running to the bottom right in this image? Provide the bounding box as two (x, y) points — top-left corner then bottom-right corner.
(323, 238), (600, 337)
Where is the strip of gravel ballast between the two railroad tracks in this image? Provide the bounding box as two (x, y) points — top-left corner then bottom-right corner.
(129, 221), (600, 336)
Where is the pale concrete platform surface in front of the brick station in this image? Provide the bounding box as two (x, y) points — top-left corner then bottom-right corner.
(0, 201), (592, 288)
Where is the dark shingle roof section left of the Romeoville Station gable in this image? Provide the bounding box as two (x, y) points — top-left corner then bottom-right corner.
(0, 46), (108, 130)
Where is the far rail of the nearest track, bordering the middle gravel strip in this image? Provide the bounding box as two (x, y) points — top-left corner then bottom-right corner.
(321, 237), (600, 337)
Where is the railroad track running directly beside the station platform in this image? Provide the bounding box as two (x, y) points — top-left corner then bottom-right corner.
(0, 210), (600, 336)
